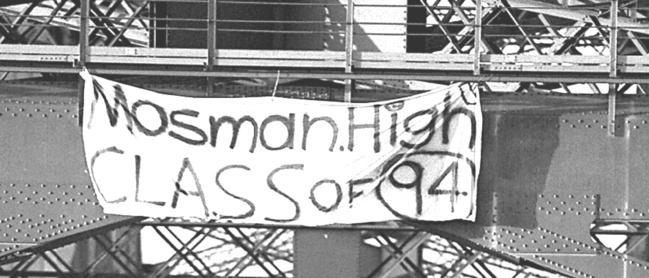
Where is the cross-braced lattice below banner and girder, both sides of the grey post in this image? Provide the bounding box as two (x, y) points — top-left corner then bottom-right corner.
(0, 219), (559, 277)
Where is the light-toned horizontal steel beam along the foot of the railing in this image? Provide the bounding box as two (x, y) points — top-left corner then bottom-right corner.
(0, 44), (649, 74)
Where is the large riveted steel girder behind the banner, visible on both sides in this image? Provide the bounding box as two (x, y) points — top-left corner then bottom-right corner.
(5, 79), (649, 277)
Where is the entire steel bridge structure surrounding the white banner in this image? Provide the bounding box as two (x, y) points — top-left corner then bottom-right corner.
(0, 0), (649, 278)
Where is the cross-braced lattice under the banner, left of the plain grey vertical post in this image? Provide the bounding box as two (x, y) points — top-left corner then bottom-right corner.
(142, 221), (293, 277)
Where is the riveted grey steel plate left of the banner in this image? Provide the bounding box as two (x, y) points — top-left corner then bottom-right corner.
(0, 85), (134, 261)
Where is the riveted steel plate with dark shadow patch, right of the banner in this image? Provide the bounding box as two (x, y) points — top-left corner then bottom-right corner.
(429, 94), (649, 277)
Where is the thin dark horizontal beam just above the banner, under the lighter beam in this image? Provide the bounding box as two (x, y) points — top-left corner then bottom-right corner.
(5, 65), (649, 84)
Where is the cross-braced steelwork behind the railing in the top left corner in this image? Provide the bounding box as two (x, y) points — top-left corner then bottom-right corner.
(0, 0), (150, 47)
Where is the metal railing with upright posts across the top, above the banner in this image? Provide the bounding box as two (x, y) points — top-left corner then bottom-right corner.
(0, 0), (649, 83)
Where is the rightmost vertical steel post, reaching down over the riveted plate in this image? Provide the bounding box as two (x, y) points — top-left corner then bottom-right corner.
(608, 0), (618, 136)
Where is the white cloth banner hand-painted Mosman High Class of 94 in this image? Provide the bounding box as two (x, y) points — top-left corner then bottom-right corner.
(82, 72), (482, 226)
